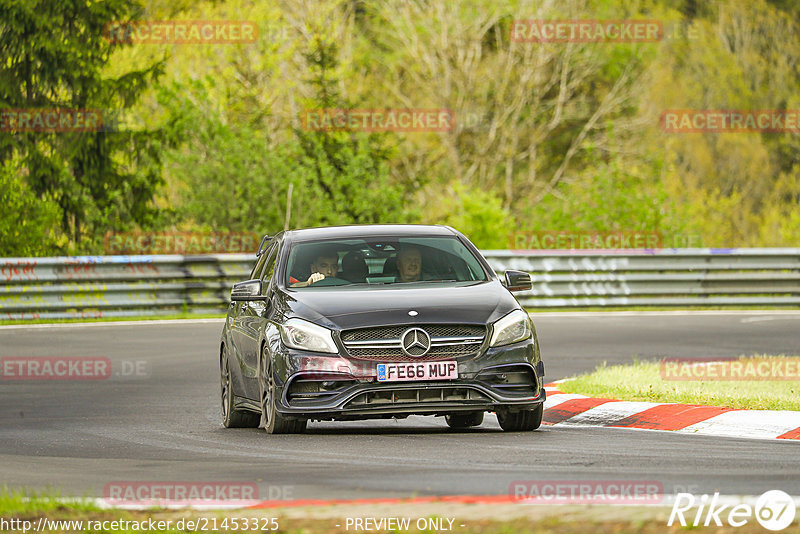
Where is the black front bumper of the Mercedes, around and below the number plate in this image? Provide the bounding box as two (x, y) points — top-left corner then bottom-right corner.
(276, 341), (545, 420)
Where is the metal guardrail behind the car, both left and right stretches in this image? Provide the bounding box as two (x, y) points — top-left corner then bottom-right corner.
(0, 248), (800, 320)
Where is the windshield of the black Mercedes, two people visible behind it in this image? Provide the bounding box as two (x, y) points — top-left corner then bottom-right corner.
(286, 237), (487, 288)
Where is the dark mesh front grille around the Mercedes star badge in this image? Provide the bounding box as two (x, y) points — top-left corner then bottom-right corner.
(342, 324), (486, 362)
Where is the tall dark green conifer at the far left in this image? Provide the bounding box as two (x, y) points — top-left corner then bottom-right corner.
(0, 0), (163, 250)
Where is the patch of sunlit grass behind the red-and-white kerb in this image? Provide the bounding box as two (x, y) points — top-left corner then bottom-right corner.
(559, 356), (800, 411)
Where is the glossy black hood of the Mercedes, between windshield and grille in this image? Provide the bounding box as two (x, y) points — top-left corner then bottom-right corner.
(288, 280), (520, 330)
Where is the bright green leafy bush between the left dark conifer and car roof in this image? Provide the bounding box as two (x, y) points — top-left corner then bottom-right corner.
(155, 80), (296, 233)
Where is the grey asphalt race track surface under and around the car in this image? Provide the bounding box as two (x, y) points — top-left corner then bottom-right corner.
(0, 312), (800, 499)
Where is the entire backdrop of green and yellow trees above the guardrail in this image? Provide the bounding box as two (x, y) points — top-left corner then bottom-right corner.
(0, 0), (800, 254)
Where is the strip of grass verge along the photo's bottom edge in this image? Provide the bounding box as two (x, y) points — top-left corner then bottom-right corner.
(0, 490), (780, 534)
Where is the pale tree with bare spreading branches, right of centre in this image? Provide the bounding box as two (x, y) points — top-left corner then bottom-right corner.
(366, 0), (648, 217)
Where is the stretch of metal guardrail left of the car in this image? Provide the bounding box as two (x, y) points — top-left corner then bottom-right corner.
(0, 254), (255, 320)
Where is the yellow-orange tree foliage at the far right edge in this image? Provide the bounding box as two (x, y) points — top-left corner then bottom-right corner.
(644, 0), (800, 247)
